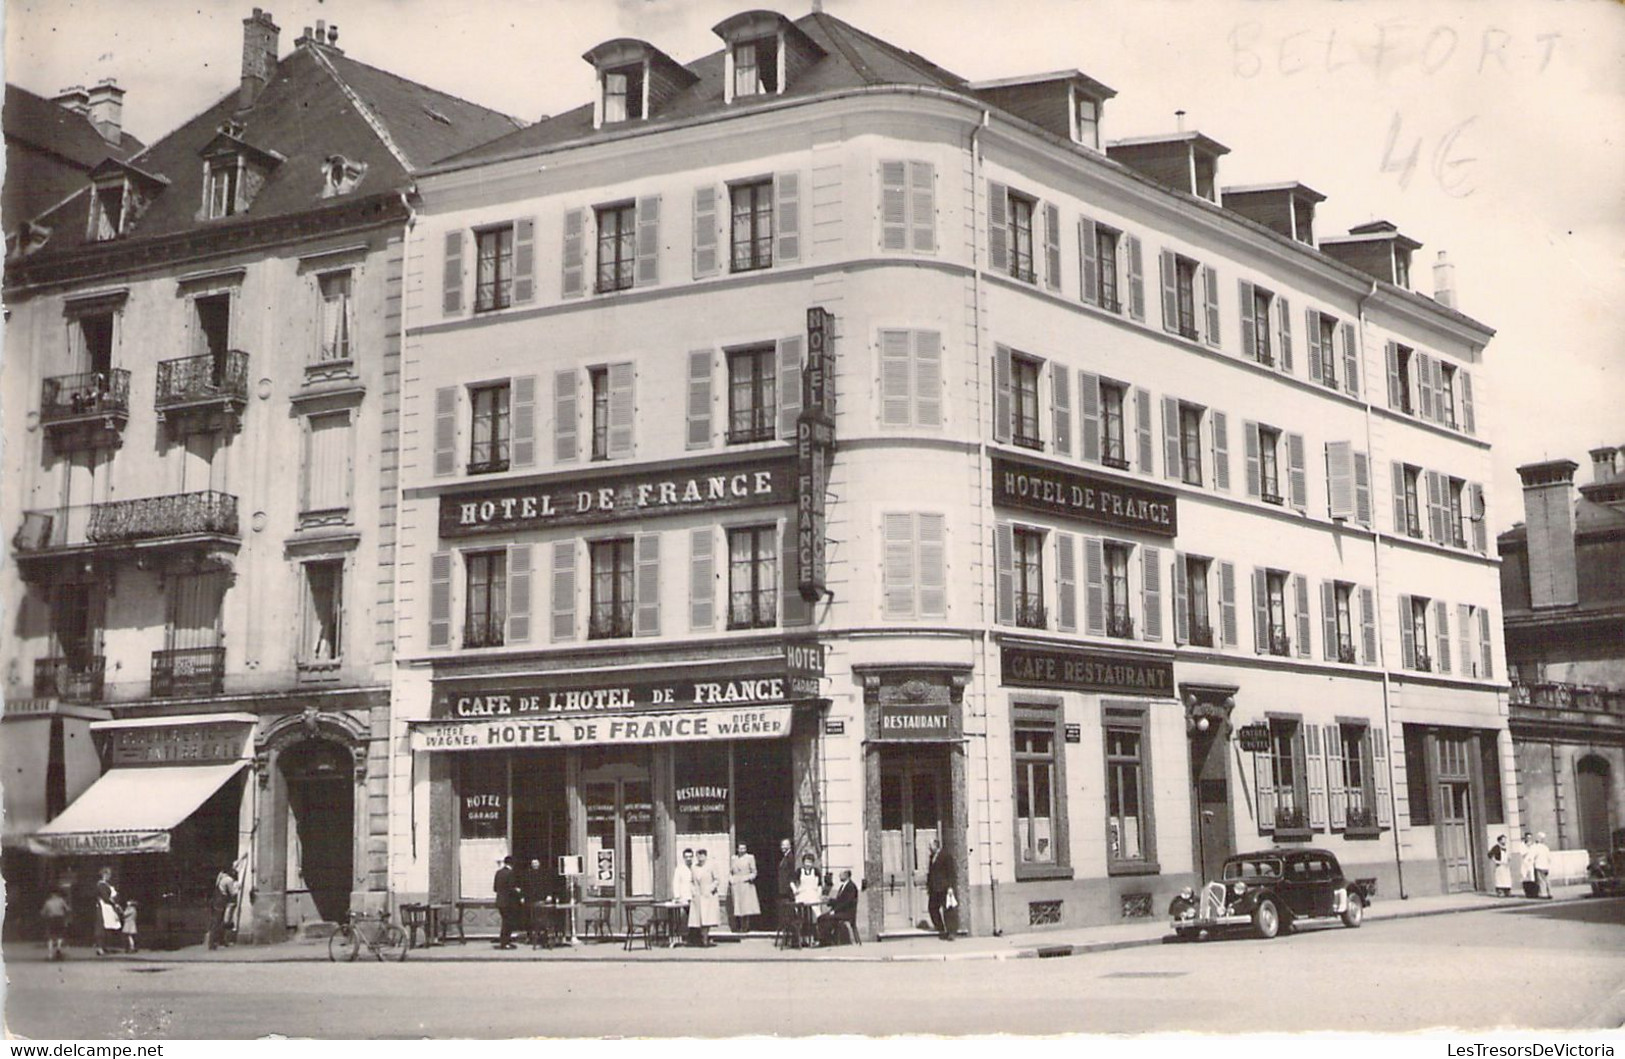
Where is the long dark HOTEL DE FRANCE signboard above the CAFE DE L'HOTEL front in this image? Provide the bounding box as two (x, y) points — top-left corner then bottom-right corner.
(440, 456), (795, 538)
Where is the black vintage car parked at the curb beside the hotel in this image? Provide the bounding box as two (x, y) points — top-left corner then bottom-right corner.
(1168, 849), (1376, 939)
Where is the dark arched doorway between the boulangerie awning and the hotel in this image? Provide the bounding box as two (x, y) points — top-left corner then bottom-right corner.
(278, 739), (356, 923)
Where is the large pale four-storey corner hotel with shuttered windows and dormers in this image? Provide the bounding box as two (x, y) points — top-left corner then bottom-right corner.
(390, 11), (1518, 934)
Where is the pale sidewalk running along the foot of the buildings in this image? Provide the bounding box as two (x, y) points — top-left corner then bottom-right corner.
(5, 885), (1591, 963)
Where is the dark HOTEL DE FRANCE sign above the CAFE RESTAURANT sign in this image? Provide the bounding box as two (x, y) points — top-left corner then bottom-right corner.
(993, 456), (1178, 538)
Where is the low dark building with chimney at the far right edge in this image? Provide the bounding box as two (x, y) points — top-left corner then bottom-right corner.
(1497, 445), (1625, 851)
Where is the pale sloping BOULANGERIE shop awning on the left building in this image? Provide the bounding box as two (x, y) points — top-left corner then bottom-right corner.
(28, 762), (247, 854)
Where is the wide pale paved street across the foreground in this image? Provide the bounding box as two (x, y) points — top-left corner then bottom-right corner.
(7, 900), (1625, 1038)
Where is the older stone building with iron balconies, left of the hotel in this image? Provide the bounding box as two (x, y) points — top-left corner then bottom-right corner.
(3, 10), (518, 940)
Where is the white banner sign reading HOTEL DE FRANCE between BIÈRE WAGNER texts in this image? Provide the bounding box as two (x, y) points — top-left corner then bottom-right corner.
(411, 705), (790, 750)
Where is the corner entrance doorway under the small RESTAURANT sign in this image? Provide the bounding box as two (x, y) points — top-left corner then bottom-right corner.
(881, 749), (952, 932)
